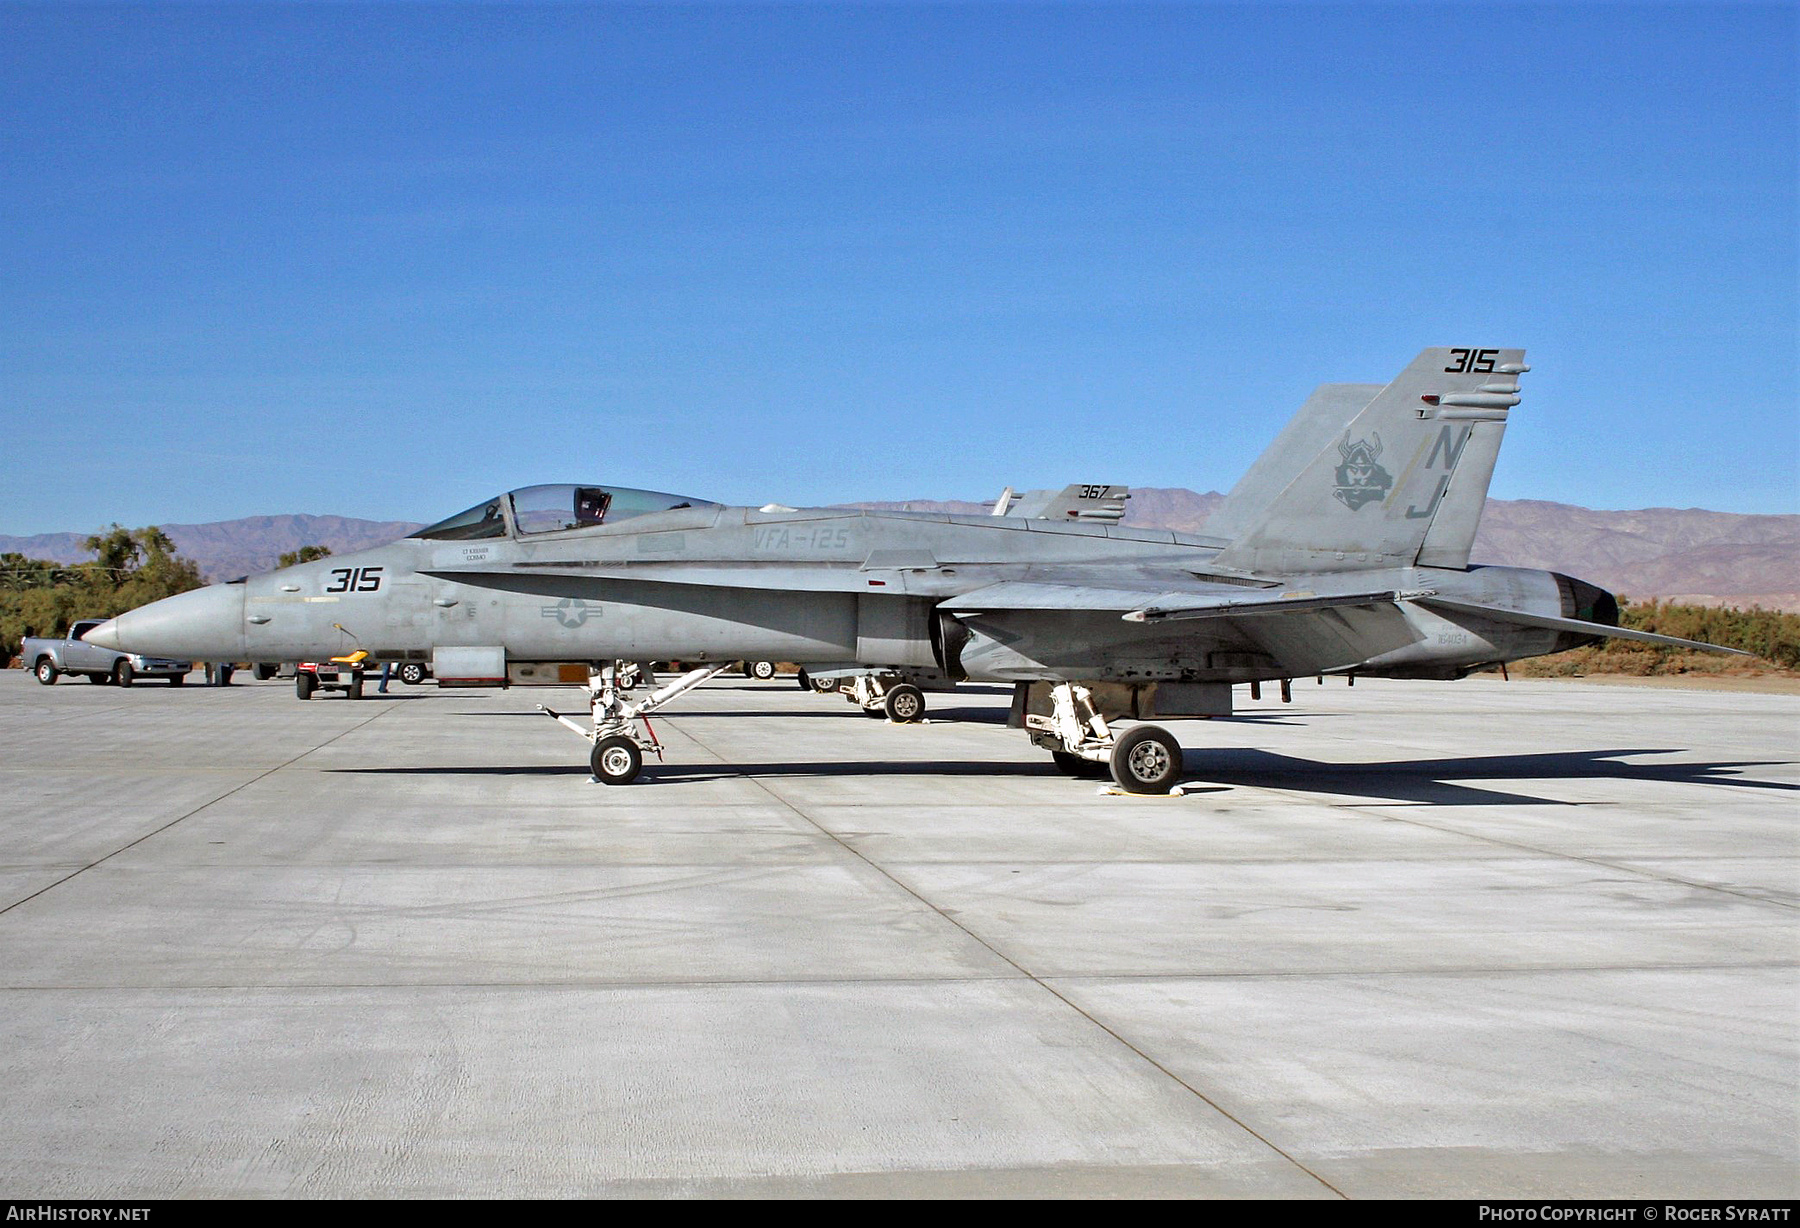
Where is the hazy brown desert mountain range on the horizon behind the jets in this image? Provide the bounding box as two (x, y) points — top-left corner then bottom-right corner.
(0, 488), (1800, 612)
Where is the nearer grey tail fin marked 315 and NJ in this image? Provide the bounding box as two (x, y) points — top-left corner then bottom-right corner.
(1213, 348), (1526, 573)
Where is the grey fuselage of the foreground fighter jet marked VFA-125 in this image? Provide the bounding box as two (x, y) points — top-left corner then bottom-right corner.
(90, 488), (1606, 682)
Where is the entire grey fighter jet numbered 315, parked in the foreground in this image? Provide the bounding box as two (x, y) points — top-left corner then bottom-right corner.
(88, 348), (1742, 792)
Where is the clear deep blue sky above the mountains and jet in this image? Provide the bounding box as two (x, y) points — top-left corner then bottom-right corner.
(0, 4), (1800, 533)
